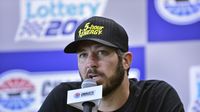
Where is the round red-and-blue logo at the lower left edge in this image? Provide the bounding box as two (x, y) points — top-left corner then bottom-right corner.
(0, 72), (35, 112)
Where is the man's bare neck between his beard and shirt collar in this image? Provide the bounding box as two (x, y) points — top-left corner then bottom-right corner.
(99, 75), (130, 111)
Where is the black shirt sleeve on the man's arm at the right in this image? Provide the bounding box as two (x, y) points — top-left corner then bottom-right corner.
(153, 81), (185, 112)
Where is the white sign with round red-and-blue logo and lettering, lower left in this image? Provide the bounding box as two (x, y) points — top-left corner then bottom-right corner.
(0, 70), (80, 112)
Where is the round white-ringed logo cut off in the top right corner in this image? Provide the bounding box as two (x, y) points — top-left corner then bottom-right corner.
(154, 0), (200, 25)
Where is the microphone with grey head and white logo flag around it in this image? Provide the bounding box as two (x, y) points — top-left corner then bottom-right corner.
(67, 79), (103, 112)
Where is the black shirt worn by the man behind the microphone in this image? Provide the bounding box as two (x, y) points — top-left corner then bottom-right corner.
(38, 79), (184, 112)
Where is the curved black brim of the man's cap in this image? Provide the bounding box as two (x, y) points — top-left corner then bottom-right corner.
(64, 38), (118, 53)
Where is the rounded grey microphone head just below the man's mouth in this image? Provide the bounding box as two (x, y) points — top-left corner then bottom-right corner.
(81, 79), (97, 88)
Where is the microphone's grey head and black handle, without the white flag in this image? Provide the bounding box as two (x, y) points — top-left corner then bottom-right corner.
(81, 79), (97, 112)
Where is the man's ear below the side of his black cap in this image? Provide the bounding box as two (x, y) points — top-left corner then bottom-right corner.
(123, 52), (133, 70)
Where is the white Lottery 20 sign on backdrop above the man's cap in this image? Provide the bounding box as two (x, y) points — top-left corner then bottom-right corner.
(15, 0), (107, 41)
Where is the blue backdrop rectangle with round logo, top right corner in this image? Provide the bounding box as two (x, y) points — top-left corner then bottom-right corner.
(148, 0), (200, 42)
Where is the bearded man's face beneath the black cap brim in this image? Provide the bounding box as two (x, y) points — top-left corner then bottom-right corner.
(77, 42), (124, 96)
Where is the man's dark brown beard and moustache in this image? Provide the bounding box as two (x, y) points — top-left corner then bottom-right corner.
(79, 60), (125, 96)
